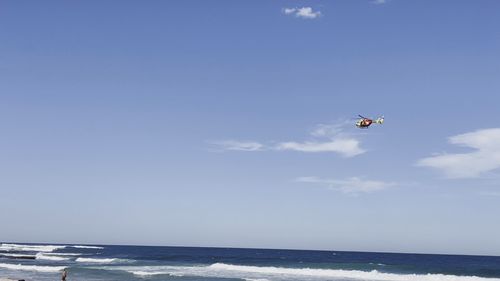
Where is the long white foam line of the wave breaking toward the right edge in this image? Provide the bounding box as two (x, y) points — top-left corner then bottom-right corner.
(111, 263), (500, 281)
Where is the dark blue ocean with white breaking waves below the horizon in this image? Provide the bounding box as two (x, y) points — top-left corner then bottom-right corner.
(0, 243), (500, 281)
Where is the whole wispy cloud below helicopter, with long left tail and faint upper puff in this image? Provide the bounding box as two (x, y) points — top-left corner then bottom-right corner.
(210, 119), (366, 157)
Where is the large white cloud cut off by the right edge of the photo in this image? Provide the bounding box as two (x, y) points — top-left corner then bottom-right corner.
(417, 128), (500, 178)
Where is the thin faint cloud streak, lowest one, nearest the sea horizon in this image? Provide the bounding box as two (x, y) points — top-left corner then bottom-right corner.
(296, 177), (396, 194)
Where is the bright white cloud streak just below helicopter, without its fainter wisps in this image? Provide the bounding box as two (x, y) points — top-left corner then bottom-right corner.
(276, 138), (365, 157)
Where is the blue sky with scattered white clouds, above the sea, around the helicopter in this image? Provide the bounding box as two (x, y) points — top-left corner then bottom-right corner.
(0, 0), (500, 255)
